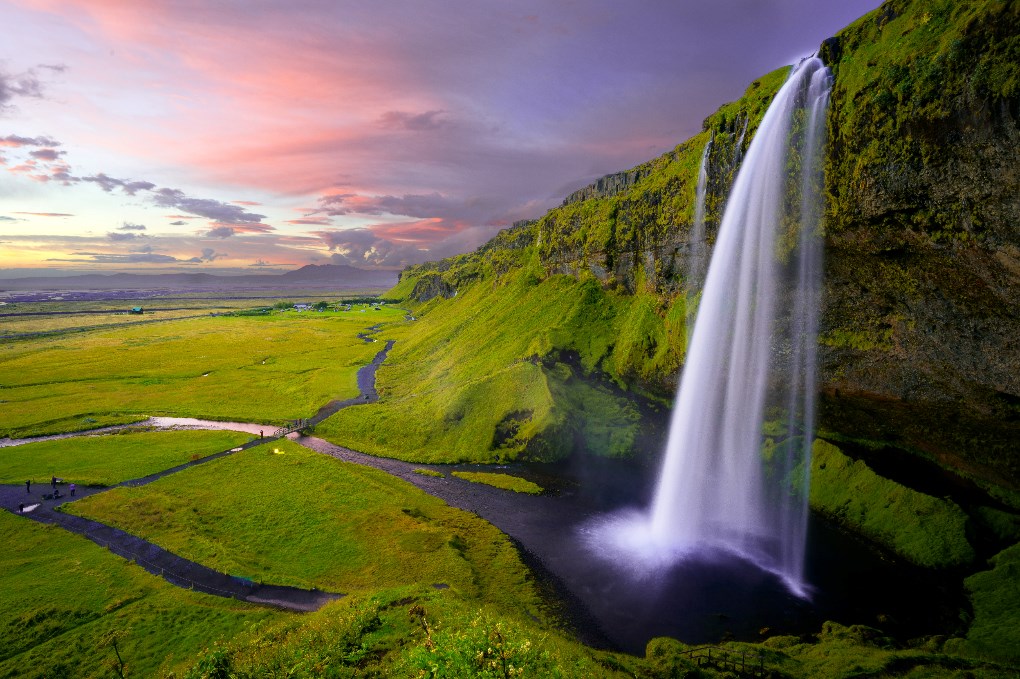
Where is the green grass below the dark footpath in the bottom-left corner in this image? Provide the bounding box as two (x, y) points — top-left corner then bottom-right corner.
(0, 512), (285, 679)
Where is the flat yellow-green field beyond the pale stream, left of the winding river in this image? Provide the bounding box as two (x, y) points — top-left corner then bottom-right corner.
(0, 308), (403, 437)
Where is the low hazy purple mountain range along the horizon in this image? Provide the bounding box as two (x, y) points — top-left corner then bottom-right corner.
(0, 264), (397, 291)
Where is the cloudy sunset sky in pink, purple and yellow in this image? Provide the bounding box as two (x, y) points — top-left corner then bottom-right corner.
(0, 0), (879, 277)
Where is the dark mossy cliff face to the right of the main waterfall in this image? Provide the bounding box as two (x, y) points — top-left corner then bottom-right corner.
(822, 0), (1020, 482)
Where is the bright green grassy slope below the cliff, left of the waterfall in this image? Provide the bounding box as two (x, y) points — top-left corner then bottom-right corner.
(316, 272), (652, 462)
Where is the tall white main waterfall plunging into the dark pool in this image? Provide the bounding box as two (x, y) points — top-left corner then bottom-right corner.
(596, 57), (830, 595)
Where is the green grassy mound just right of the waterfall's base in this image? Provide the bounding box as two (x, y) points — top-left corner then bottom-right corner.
(810, 439), (974, 568)
